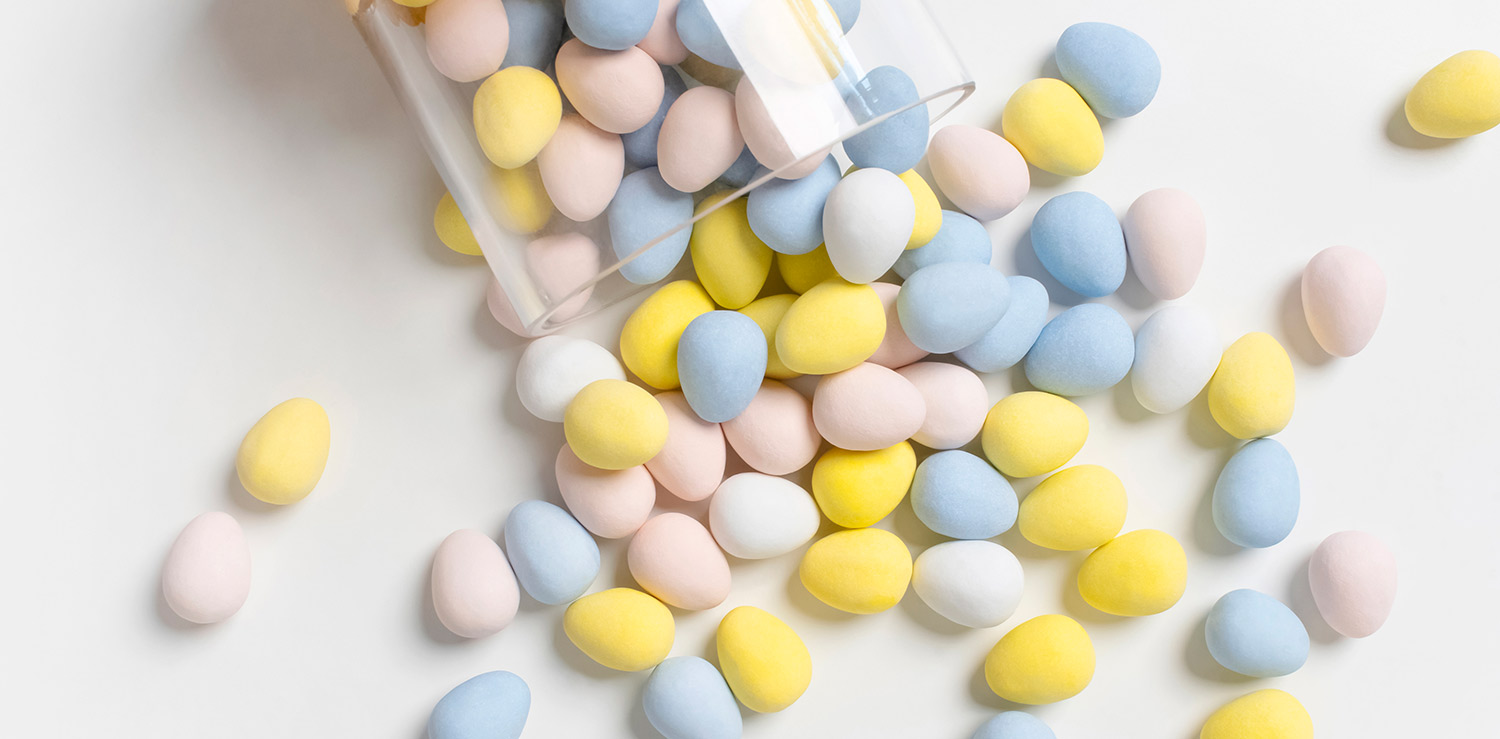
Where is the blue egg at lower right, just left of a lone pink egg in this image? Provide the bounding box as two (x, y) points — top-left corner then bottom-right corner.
(1203, 591), (1308, 678)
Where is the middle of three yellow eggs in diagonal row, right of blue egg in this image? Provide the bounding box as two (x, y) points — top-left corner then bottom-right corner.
(1019, 465), (1127, 552)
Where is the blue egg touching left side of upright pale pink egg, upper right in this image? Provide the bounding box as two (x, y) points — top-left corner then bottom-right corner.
(1031, 192), (1125, 298)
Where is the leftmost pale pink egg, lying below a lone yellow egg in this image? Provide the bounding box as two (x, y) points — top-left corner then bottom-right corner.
(162, 511), (251, 624)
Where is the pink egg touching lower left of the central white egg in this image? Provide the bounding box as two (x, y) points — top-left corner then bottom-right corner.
(626, 513), (729, 610)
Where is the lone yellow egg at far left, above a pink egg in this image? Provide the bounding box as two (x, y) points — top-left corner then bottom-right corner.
(234, 397), (329, 505)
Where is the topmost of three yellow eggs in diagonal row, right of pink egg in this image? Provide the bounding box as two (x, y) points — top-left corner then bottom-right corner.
(980, 390), (1089, 477)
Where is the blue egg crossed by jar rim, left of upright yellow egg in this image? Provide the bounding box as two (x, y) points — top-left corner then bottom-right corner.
(606, 166), (693, 283)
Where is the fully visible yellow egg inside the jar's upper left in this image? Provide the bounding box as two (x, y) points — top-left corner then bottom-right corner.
(474, 66), (563, 169)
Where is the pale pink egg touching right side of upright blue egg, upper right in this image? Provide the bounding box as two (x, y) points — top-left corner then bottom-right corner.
(1121, 187), (1209, 300)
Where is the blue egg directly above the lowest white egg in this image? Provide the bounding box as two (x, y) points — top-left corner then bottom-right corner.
(912, 450), (1019, 538)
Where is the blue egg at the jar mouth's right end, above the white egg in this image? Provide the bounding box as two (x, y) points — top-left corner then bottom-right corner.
(845, 66), (927, 174)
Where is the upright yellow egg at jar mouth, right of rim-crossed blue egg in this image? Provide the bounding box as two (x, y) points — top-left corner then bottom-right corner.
(687, 192), (773, 310)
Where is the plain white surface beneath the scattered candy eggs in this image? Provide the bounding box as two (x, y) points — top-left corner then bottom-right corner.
(0, 0), (1500, 739)
